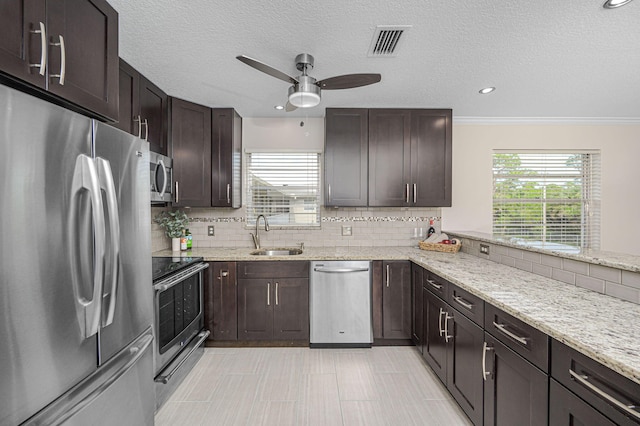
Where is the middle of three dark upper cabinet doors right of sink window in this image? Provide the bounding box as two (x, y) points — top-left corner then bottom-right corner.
(369, 109), (411, 207)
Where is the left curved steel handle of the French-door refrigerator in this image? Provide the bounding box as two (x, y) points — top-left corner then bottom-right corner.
(67, 154), (105, 339)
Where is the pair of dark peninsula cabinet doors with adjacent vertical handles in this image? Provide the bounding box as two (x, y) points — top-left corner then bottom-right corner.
(422, 288), (484, 425)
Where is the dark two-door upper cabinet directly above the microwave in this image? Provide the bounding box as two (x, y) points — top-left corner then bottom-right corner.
(114, 59), (169, 155)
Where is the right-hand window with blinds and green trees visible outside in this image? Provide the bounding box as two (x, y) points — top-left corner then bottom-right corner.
(493, 151), (600, 251)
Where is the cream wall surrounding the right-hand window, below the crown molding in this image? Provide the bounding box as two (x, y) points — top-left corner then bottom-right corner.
(442, 124), (640, 255)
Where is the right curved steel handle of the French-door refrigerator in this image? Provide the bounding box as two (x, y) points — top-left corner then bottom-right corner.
(95, 157), (120, 327)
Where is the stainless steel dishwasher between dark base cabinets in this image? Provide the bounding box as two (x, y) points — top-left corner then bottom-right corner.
(309, 260), (373, 348)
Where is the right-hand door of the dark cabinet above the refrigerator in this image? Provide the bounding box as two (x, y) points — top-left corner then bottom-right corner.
(46, 0), (119, 121)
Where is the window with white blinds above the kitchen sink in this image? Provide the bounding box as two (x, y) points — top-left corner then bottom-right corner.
(245, 152), (320, 226)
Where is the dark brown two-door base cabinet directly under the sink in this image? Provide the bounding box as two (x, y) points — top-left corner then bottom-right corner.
(238, 262), (309, 340)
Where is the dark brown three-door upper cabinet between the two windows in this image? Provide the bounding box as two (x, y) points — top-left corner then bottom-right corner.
(325, 108), (452, 207)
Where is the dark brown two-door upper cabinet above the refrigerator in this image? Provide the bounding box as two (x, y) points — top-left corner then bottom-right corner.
(0, 0), (119, 121)
